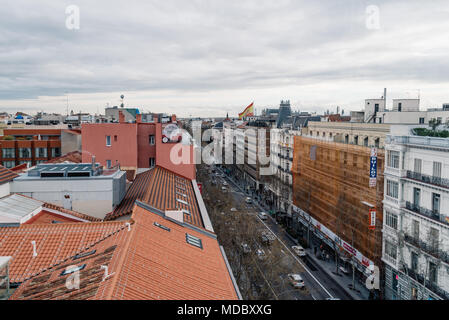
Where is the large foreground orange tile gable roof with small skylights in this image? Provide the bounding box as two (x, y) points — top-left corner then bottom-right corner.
(11, 203), (237, 300)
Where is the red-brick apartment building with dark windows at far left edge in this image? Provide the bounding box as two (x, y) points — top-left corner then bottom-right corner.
(0, 127), (62, 168)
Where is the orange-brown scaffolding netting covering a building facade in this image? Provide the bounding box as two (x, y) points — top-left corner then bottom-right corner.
(292, 136), (384, 266)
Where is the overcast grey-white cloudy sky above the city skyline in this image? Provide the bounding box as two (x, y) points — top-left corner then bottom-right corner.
(0, 0), (449, 117)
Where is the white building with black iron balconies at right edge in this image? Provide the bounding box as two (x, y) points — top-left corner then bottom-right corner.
(382, 130), (449, 300)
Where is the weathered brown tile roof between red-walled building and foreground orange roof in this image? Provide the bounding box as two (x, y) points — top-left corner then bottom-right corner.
(105, 166), (204, 228)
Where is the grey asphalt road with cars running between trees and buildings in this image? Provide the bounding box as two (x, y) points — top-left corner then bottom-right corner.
(213, 168), (352, 300)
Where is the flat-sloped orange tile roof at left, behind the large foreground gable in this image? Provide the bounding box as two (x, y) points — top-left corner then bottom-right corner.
(0, 221), (130, 282)
